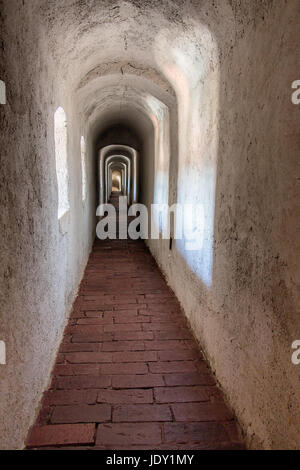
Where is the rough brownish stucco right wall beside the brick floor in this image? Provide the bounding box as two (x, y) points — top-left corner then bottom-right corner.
(150, 1), (300, 449)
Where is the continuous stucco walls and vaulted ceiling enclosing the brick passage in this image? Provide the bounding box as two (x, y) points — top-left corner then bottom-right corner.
(0, 0), (300, 448)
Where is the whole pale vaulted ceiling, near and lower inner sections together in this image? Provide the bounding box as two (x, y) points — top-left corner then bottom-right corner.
(36, 0), (234, 138)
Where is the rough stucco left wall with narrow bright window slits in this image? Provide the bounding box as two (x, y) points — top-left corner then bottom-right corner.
(0, 1), (94, 449)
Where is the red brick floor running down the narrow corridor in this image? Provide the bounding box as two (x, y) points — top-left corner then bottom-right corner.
(27, 235), (244, 450)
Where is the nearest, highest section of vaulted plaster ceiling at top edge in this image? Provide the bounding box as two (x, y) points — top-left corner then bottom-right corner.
(37, 0), (237, 86)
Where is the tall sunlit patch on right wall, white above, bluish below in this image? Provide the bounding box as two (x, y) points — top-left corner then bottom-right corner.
(156, 26), (220, 287)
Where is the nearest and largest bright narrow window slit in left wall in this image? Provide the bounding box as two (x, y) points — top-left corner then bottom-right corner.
(54, 107), (70, 219)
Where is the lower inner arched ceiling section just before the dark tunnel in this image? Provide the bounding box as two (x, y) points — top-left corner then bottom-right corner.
(76, 71), (176, 138)
